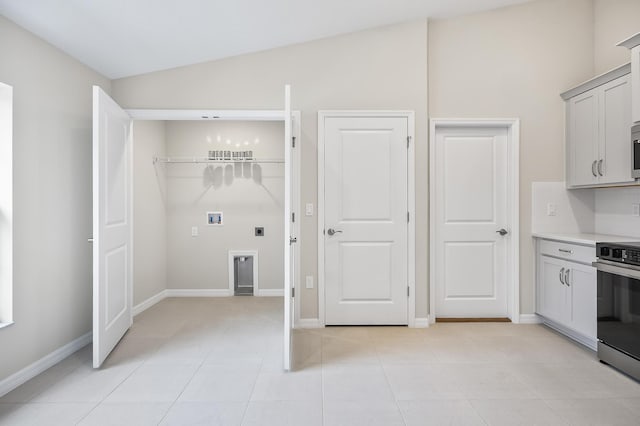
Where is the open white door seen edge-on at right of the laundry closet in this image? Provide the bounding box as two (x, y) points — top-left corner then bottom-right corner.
(284, 85), (297, 371)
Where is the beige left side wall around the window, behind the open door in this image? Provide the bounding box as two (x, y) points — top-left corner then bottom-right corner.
(0, 17), (110, 381)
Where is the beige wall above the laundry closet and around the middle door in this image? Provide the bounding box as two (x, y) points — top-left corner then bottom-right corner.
(112, 20), (428, 318)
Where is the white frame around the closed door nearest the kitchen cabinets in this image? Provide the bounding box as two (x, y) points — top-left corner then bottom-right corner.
(429, 118), (520, 324)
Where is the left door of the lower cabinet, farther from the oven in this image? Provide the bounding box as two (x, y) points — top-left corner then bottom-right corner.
(536, 255), (568, 323)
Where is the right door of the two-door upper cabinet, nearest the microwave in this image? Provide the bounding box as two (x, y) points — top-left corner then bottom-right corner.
(596, 75), (634, 183)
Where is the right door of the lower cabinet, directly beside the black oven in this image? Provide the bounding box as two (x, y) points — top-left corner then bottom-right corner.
(566, 263), (597, 339)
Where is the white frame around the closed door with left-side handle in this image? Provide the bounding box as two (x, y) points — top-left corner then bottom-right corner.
(317, 110), (416, 327)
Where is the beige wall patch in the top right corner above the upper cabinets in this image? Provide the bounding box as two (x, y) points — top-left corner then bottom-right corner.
(594, 0), (640, 74)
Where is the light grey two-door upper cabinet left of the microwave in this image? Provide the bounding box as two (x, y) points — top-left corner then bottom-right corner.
(561, 64), (635, 188)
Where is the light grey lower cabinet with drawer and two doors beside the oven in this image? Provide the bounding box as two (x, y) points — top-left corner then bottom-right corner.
(536, 240), (597, 349)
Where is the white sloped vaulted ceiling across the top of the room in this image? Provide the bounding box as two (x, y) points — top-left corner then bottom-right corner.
(0, 0), (526, 78)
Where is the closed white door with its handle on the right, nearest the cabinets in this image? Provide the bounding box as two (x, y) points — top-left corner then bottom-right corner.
(431, 127), (511, 318)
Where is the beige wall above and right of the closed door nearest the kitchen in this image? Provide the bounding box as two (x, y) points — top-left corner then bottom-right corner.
(429, 0), (593, 314)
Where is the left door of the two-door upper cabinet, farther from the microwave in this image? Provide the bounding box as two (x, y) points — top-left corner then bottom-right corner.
(567, 89), (598, 186)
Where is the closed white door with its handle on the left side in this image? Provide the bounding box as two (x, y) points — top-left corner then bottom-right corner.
(319, 117), (408, 325)
